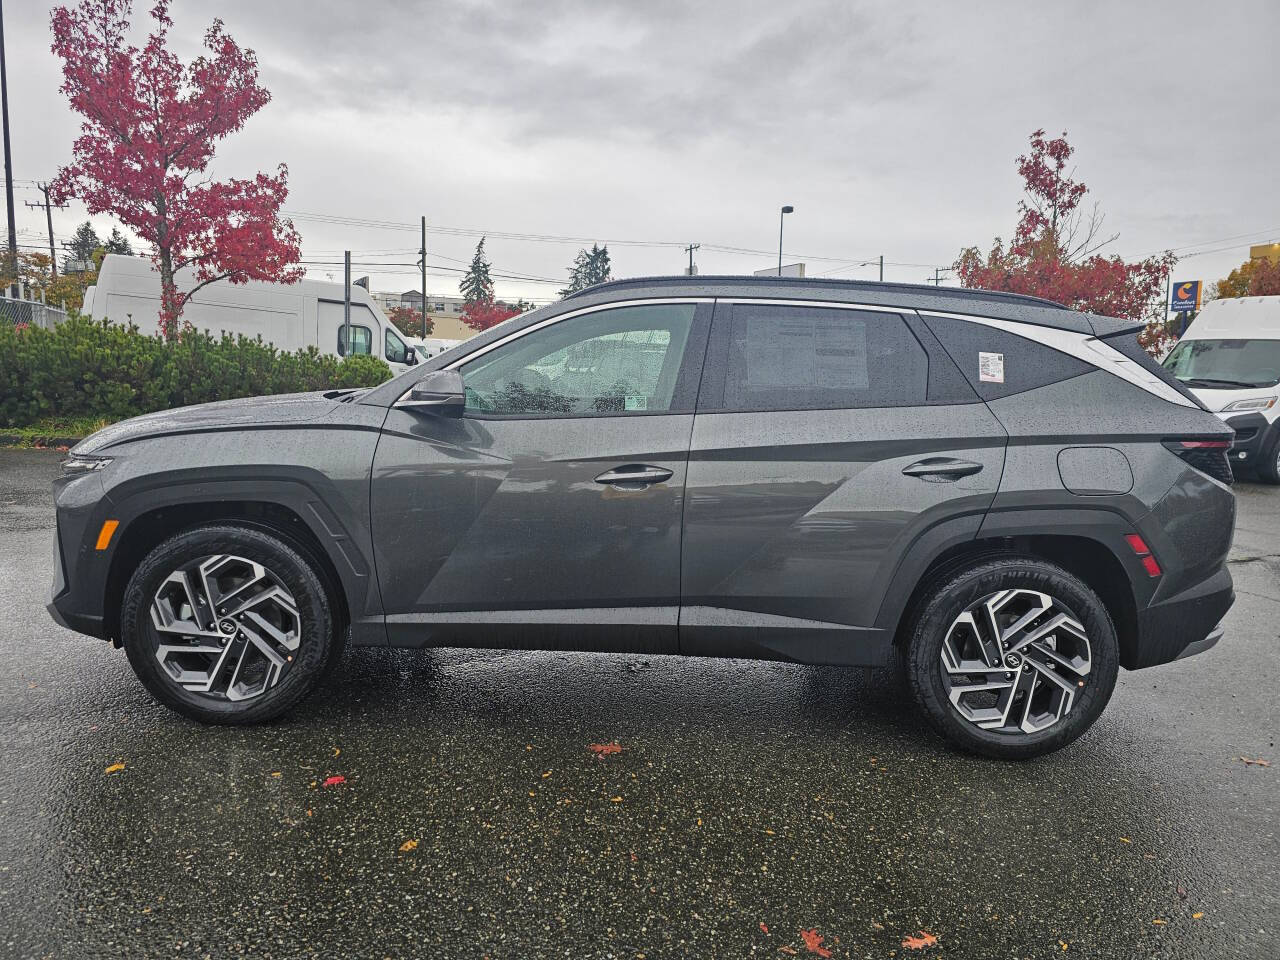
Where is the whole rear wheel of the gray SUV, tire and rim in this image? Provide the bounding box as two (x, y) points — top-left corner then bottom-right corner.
(905, 557), (1119, 759)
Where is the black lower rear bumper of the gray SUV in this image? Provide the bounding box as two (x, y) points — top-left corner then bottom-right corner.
(1120, 567), (1235, 669)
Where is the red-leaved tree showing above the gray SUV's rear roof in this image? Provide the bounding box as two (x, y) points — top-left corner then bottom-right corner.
(954, 129), (1176, 348)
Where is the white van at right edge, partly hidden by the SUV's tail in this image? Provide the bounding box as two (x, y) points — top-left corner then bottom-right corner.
(1164, 297), (1280, 484)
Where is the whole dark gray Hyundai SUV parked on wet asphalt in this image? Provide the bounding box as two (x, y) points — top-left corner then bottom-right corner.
(50, 278), (1235, 758)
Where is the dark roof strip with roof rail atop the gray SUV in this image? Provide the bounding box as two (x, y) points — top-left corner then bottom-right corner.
(562, 275), (1098, 334)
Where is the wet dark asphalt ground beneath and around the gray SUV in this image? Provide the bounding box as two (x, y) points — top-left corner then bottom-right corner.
(0, 449), (1280, 960)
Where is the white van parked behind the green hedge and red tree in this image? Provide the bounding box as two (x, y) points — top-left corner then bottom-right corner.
(81, 253), (419, 374)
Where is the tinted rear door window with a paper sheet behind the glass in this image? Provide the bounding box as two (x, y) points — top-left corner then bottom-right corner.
(723, 303), (929, 410)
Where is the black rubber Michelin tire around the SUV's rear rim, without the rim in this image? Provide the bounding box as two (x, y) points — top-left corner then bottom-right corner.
(904, 556), (1120, 760)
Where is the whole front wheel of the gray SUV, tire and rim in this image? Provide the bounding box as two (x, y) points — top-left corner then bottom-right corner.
(120, 525), (339, 723)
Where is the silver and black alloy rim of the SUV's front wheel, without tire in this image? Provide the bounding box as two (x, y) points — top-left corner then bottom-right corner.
(151, 554), (302, 701)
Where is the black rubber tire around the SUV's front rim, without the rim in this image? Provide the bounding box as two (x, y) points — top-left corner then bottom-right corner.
(120, 524), (342, 724)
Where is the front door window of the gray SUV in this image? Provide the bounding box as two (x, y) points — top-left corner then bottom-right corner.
(461, 303), (695, 417)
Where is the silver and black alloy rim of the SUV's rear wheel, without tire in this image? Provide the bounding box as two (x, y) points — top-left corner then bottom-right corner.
(942, 589), (1092, 733)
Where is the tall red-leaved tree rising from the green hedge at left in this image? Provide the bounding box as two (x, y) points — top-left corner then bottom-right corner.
(50, 0), (302, 337)
